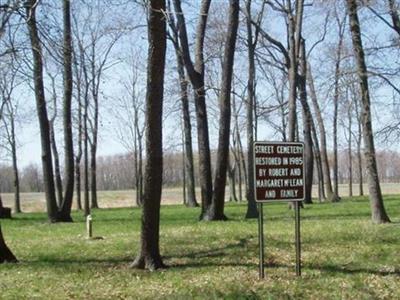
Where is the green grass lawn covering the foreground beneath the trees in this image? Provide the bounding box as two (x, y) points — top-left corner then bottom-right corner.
(0, 195), (400, 299)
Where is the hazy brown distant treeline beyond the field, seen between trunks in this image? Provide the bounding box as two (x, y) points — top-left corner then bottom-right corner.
(0, 149), (400, 195)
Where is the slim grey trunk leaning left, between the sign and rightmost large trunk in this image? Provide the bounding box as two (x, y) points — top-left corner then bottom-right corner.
(307, 64), (339, 202)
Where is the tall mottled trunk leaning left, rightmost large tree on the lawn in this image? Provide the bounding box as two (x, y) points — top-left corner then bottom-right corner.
(347, 0), (390, 223)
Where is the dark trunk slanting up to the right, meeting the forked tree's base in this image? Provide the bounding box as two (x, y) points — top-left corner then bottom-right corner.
(203, 0), (239, 221)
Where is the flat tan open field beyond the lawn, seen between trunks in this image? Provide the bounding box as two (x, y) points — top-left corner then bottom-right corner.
(2, 183), (400, 212)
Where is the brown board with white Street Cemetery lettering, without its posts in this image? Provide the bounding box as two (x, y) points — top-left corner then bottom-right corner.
(254, 142), (304, 202)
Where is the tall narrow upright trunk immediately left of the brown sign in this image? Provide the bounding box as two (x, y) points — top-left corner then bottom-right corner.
(245, 0), (258, 219)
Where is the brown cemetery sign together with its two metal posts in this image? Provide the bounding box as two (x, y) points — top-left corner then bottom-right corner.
(253, 142), (305, 279)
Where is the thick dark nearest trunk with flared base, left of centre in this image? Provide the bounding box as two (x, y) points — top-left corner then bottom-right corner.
(132, 0), (166, 270)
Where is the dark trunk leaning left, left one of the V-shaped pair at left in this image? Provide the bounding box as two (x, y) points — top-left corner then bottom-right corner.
(26, 0), (57, 222)
